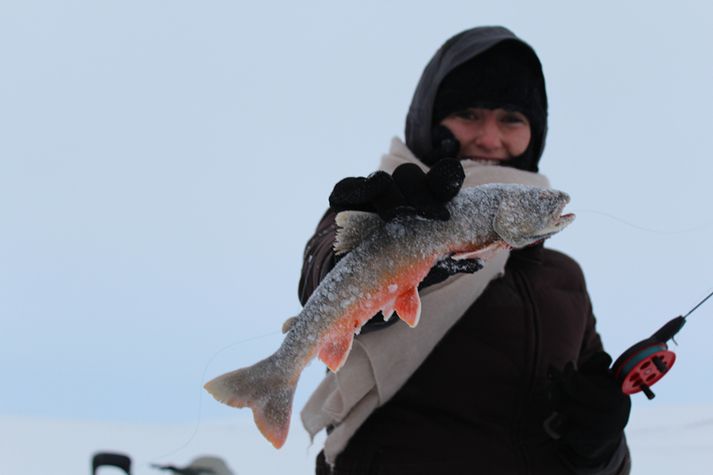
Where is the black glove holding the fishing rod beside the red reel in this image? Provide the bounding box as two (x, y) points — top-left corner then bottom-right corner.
(545, 351), (631, 467)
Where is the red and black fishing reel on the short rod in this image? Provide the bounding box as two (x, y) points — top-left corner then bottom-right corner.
(611, 318), (690, 399)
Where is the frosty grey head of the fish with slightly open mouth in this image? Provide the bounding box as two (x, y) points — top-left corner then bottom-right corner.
(493, 185), (574, 248)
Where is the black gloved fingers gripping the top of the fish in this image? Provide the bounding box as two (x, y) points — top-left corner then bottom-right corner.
(329, 159), (465, 221)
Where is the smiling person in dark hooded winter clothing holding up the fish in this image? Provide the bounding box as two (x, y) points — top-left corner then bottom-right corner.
(299, 27), (631, 474)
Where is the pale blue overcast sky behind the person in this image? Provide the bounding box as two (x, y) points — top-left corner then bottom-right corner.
(0, 0), (713, 468)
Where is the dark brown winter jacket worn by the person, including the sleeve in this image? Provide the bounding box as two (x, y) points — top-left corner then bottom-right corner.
(299, 212), (629, 475)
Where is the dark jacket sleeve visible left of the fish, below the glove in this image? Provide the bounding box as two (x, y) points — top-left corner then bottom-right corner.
(298, 210), (337, 305)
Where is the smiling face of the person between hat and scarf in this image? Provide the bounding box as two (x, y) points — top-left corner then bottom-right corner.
(440, 107), (532, 161)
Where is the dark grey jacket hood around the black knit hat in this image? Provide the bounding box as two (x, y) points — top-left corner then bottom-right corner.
(405, 26), (547, 171)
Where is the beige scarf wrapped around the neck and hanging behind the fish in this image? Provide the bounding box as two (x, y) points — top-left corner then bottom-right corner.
(301, 138), (549, 464)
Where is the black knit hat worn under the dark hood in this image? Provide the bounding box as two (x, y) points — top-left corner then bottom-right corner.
(432, 40), (547, 171)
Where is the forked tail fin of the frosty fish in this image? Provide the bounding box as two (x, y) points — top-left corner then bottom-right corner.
(203, 355), (297, 449)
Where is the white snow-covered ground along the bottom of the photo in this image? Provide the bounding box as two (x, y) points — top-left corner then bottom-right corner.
(0, 401), (713, 475)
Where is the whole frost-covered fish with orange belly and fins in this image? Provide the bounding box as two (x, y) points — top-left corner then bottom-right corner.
(205, 184), (574, 448)
